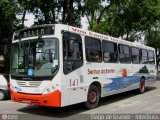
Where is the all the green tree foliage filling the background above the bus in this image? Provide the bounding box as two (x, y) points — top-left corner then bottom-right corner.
(0, 0), (160, 48)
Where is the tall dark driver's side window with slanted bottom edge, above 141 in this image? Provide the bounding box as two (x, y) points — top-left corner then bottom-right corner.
(63, 32), (83, 74)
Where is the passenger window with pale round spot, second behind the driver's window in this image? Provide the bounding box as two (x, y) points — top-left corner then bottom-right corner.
(102, 41), (118, 63)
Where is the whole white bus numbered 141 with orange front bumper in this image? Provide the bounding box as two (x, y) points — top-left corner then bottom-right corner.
(10, 24), (157, 109)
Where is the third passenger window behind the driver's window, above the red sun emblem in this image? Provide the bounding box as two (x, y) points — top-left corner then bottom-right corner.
(119, 44), (131, 63)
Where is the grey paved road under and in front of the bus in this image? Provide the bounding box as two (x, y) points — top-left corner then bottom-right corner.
(0, 81), (160, 120)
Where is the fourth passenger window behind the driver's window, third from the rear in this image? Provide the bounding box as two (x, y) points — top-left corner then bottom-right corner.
(131, 47), (140, 64)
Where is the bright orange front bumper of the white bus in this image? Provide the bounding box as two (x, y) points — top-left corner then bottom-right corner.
(10, 89), (61, 107)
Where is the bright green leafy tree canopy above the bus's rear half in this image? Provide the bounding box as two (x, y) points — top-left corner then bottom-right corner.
(92, 0), (160, 44)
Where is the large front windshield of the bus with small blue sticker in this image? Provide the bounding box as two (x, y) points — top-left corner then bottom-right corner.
(11, 38), (59, 76)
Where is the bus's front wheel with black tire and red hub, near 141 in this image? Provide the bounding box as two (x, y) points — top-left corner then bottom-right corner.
(85, 85), (100, 109)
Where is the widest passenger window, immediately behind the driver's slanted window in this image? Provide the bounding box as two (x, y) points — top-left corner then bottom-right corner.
(85, 37), (102, 62)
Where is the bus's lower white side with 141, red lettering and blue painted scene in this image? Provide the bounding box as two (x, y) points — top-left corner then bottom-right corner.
(62, 62), (156, 106)
